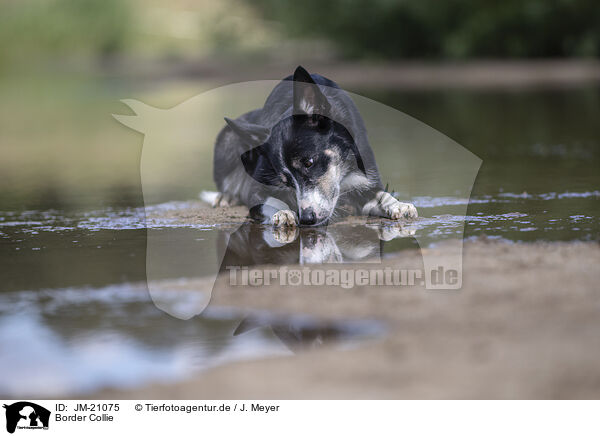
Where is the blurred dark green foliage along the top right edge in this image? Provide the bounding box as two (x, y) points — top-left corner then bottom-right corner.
(248, 0), (600, 58)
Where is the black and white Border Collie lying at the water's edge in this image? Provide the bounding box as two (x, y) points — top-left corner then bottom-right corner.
(214, 66), (417, 226)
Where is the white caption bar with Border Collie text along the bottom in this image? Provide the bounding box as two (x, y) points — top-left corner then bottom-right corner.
(2, 400), (600, 436)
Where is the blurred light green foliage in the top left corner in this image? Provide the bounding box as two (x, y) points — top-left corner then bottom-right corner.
(0, 0), (131, 68)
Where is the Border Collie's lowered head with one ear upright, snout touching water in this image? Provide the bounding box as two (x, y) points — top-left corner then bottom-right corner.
(226, 67), (366, 225)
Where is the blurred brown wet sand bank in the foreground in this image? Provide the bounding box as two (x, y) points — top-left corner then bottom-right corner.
(94, 204), (600, 399)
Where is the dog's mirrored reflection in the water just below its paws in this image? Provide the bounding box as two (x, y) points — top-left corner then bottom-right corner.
(219, 222), (415, 272)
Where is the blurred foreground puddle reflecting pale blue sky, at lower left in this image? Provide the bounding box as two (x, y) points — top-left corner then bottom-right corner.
(0, 284), (383, 398)
